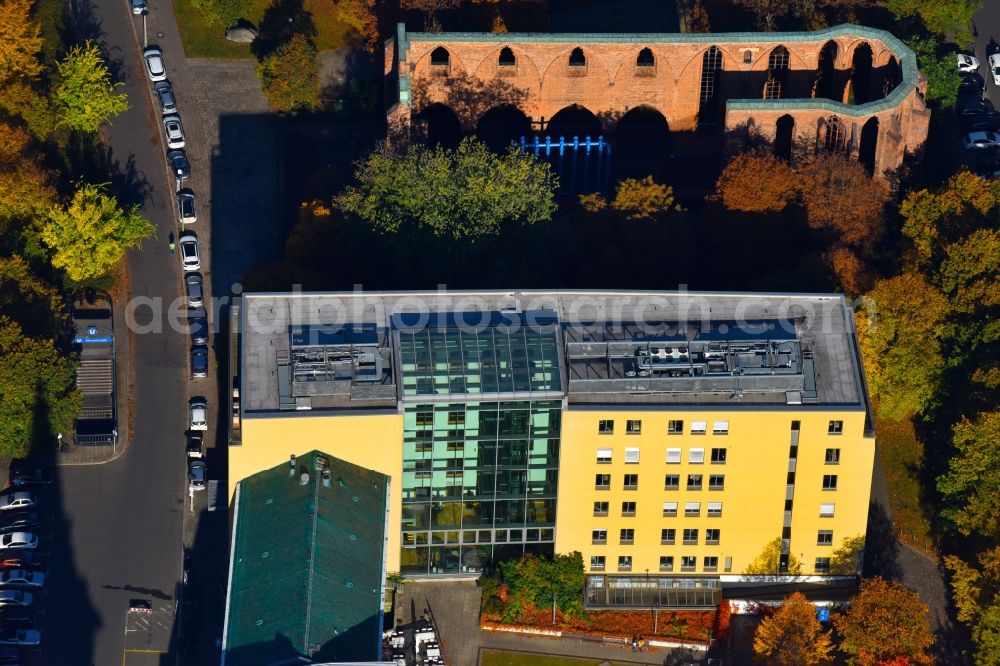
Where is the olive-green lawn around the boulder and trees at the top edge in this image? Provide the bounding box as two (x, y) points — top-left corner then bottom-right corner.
(174, 0), (351, 58)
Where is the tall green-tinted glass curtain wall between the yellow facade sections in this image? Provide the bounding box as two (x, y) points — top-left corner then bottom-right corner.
(401, 400), (561, 575)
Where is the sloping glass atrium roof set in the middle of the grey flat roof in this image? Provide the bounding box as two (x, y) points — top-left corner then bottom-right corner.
(398, 314), (562, 397)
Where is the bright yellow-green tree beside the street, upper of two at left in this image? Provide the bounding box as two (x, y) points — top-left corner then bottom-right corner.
(52, 41), (128, 132)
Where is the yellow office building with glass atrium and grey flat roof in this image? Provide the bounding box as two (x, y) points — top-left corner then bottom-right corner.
(229, 291), (875, 605)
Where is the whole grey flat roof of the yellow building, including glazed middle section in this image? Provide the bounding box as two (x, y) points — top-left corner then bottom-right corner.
(240, 290), (867, 416)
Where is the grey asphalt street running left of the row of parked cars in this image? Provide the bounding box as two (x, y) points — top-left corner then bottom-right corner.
(34, 0), (187, 666)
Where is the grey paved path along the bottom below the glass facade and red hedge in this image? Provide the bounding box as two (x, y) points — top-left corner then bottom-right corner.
(397, 581), (703, 666)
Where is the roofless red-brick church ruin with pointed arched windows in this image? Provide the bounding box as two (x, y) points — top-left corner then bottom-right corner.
(385, 24), (930, 177)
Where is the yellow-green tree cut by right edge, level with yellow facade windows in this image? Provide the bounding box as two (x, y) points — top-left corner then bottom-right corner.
(937, 411), (1000, 536)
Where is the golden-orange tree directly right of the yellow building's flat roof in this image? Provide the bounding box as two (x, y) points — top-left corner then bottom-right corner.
(856, 273), (948, 419)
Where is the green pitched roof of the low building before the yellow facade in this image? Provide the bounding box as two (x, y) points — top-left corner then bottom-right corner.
(223, 451), (388, 666)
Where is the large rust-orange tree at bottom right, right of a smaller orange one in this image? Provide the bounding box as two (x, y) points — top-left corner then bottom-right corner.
(833, 578), (934, 666)
